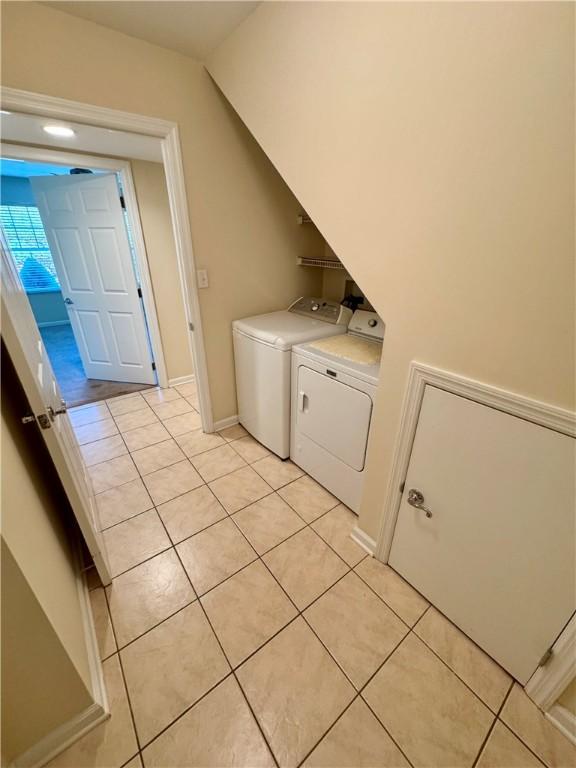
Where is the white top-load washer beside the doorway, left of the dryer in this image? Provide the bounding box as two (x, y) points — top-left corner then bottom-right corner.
(232, 297), (352, 459)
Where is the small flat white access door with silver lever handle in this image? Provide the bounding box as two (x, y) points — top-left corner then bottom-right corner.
(389, 386), (576, 683)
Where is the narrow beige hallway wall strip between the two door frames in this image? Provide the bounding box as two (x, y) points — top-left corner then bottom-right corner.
(131, 160), (194, 379)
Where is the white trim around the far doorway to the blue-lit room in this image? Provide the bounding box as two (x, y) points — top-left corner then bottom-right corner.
(8, 142), (168, 387)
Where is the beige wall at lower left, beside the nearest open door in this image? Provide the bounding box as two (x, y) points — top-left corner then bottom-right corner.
(1, 396), (93, 764)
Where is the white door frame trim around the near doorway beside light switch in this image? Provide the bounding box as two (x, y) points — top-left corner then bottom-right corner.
(2, 88), (214, 432)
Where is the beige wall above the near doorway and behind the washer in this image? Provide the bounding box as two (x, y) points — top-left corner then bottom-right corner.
(2, 2), (320, 420)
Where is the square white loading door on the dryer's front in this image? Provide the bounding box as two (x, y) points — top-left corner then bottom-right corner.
(296, 365), (372, 472)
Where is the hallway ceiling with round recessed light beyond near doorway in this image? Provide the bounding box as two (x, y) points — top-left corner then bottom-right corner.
(1, 112), (162, 163)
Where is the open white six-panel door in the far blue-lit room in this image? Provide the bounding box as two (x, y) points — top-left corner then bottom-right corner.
(30, 173), (156, 384)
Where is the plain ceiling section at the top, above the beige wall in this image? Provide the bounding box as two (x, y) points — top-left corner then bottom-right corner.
(46, 0), (259, 60)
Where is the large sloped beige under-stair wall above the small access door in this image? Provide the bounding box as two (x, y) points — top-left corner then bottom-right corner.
(208, 2), (575, 537)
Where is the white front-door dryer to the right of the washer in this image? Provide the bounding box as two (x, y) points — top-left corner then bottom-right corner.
(290, 310), (384, 512)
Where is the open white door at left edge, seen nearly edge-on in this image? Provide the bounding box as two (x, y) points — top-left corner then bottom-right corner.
(0, 239), (111, 585)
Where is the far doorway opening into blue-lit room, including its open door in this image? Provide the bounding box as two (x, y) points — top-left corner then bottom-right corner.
(0, 158), (158, 407)
